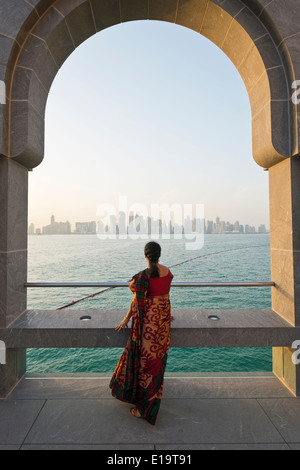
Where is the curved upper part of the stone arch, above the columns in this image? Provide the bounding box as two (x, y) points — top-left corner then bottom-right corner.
(2, 0), (298, 168)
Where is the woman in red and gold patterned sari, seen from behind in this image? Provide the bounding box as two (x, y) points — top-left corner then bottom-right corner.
(110, 242), (173, 425)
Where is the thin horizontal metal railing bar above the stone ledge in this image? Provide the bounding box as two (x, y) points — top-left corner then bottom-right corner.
(24, 281), (275, 288)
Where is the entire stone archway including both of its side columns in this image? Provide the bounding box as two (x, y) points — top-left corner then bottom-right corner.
(0, 0), (300, 397)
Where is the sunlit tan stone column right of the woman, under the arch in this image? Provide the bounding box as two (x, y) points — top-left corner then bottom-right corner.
(269, 157), (300, 396)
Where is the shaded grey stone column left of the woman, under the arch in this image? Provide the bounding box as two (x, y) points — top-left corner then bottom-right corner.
(0, 157), (28, 398)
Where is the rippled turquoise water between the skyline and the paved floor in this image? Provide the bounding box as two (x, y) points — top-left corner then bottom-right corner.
(27, 234), (272, 373)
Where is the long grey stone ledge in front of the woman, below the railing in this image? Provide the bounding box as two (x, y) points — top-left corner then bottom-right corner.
(0, 309), (300, 348)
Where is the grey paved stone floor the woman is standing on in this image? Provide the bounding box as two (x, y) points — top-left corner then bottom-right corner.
(0, 374), (300, 450)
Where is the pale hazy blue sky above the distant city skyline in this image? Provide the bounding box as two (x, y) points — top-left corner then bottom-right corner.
(29, 21), (269, 229)
